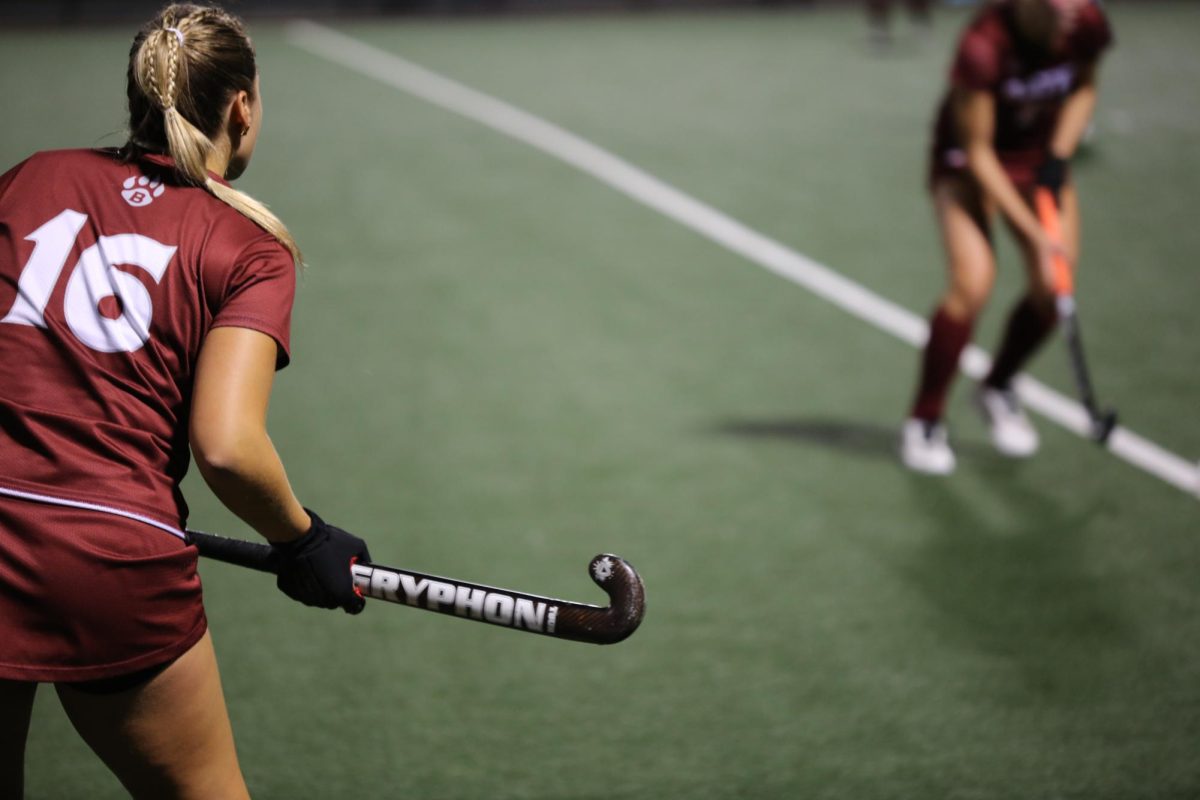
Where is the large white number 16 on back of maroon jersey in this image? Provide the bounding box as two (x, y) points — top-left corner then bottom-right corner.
(0, 209), (178, 353)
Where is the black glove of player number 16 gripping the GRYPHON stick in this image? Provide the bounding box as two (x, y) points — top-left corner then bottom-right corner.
(271, 509), (371, 614)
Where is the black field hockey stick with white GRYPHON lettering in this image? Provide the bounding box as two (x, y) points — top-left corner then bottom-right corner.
(187, 530), (646, 644)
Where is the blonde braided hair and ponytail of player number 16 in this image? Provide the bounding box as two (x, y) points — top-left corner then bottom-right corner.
(127, 4), (304, 264)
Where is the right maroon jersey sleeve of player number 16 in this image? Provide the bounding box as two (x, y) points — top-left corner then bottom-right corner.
(210, 231), (296, 369)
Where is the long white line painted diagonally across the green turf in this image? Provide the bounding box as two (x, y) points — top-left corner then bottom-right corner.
(287, 20), (1200, 494)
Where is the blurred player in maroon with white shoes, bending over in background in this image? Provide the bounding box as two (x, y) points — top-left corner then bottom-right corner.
(900, 0), (1111, 474)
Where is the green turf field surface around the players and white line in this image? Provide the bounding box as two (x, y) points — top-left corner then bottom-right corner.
(0, 2), (1200, 800)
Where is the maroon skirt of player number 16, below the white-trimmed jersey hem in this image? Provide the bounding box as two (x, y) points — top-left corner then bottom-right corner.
(0, 497), (208, 682)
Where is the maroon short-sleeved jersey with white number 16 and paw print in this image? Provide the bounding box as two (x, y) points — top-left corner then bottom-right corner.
(0, 150), (295, 536)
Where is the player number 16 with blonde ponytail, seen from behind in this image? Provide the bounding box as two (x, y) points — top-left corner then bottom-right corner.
(0, 5), (368, 799)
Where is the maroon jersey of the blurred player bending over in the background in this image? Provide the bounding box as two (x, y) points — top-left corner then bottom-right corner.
(932, 0), (1112, 184)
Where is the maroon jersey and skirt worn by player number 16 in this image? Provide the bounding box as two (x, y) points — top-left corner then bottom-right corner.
(0, 150), (295, 680)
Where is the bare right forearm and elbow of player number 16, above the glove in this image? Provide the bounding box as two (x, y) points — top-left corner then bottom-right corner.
(190, 327), (312, 542)
